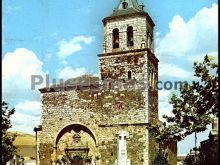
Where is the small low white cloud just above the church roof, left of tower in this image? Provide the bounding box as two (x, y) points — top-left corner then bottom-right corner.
(58, 66), (86, 80)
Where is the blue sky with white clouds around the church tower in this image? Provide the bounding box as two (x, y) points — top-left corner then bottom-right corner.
(2, 0), (218, 154)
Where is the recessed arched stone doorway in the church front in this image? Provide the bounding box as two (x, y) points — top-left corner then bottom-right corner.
(55, 124), (98, 165)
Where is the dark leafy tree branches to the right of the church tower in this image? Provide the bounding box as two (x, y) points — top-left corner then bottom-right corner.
(148, 55), (219, 142)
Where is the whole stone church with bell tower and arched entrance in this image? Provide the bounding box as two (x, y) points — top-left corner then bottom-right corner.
(35, 0), (176, 165)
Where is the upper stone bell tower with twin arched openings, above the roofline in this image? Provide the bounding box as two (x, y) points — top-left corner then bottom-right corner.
(98, 0), (158, 87)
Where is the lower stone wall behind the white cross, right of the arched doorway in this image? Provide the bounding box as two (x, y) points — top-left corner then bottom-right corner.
(99, 126), (148, 165)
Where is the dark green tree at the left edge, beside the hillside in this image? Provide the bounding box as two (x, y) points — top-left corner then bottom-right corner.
(1, 101), (16, 165)
